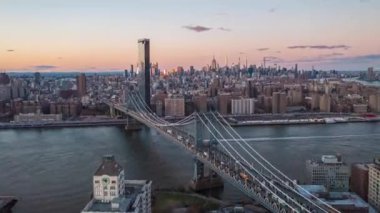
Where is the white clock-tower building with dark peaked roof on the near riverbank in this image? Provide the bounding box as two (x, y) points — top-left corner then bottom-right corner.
(82, 156), (152, 213)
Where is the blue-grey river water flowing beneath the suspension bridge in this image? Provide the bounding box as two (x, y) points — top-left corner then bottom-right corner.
(0, 123), (380, 213)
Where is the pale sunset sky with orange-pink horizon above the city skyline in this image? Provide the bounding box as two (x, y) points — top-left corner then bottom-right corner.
(0, 0), (380, 71)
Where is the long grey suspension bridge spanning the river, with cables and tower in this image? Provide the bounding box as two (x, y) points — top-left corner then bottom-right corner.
(107, 82), (339, 213)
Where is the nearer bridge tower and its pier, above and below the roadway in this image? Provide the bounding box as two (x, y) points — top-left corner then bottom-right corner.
(191, 114), (223, 191)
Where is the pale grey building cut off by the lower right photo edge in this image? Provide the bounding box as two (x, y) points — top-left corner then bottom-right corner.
(368, 158), (380, 211)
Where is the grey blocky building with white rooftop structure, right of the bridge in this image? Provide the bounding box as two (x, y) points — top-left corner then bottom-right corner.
(306, 155), (350, 192)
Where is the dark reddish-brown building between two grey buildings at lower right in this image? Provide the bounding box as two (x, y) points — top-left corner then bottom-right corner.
(350, 163), (369, 201)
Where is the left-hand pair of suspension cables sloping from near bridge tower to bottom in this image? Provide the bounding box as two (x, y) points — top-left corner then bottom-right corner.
(199, 115), (311, 212)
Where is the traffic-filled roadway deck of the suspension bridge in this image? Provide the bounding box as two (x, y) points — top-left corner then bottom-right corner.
(114, 105), (327, 213)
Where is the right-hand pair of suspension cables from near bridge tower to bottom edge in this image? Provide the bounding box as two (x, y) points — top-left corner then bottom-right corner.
(213, 112), (339, 213)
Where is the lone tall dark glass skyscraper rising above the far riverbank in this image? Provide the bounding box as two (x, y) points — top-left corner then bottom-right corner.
(138, 39), (150, 107)
